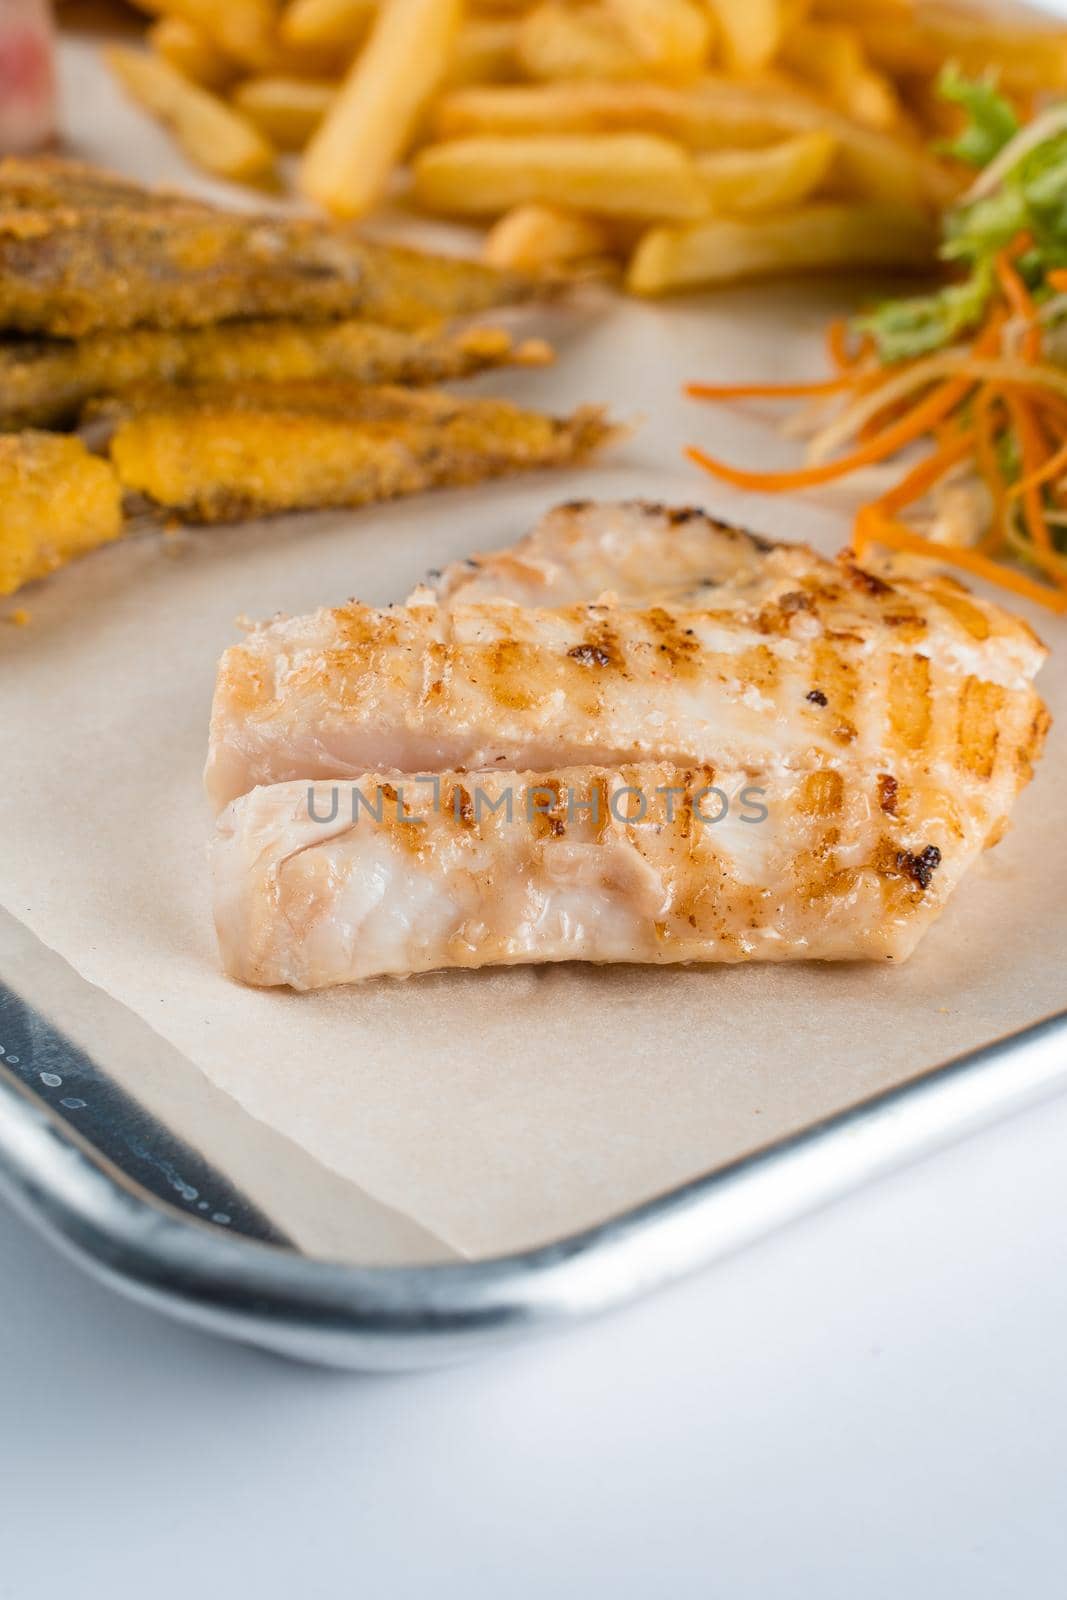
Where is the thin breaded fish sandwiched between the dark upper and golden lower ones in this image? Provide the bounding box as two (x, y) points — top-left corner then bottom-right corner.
(0, 318), (550, 429)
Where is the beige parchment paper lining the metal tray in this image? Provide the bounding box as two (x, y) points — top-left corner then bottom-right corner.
(0, 43), (1067, 1256)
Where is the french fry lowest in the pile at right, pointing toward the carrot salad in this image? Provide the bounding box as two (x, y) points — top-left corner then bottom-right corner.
(625, 202), (934, 294)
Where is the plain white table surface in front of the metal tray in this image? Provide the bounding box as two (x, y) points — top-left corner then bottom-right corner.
(0, 1075), (1067, 1600)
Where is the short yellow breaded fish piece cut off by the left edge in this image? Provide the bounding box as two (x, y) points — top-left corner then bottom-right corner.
(0, 432), (123, 595)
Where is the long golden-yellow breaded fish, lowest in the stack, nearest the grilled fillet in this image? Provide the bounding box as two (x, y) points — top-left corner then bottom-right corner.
(102, 381), (614, 522)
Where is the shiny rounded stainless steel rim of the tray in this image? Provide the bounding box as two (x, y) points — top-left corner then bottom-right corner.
(0, 1011), (1067, 1370)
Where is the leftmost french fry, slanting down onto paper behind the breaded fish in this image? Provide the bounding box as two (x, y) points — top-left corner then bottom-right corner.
(106, 45), (275, 179)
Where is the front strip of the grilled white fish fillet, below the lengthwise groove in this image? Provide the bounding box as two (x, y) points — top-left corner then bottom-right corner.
(213, 765), (1014, 989)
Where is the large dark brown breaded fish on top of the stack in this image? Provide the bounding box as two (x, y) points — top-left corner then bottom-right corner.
(0, 162), (545, 338)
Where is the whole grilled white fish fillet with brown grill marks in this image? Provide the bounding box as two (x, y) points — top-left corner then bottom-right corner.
(208, 502), (1048, 989)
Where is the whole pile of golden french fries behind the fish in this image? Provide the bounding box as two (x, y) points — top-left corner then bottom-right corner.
(109, 0), (1067, 294)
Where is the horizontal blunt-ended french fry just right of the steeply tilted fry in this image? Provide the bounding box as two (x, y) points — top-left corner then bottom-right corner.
(413, 133), (707, 221)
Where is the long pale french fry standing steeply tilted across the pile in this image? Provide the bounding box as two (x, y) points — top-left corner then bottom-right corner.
(301, 0), (461, 216)
